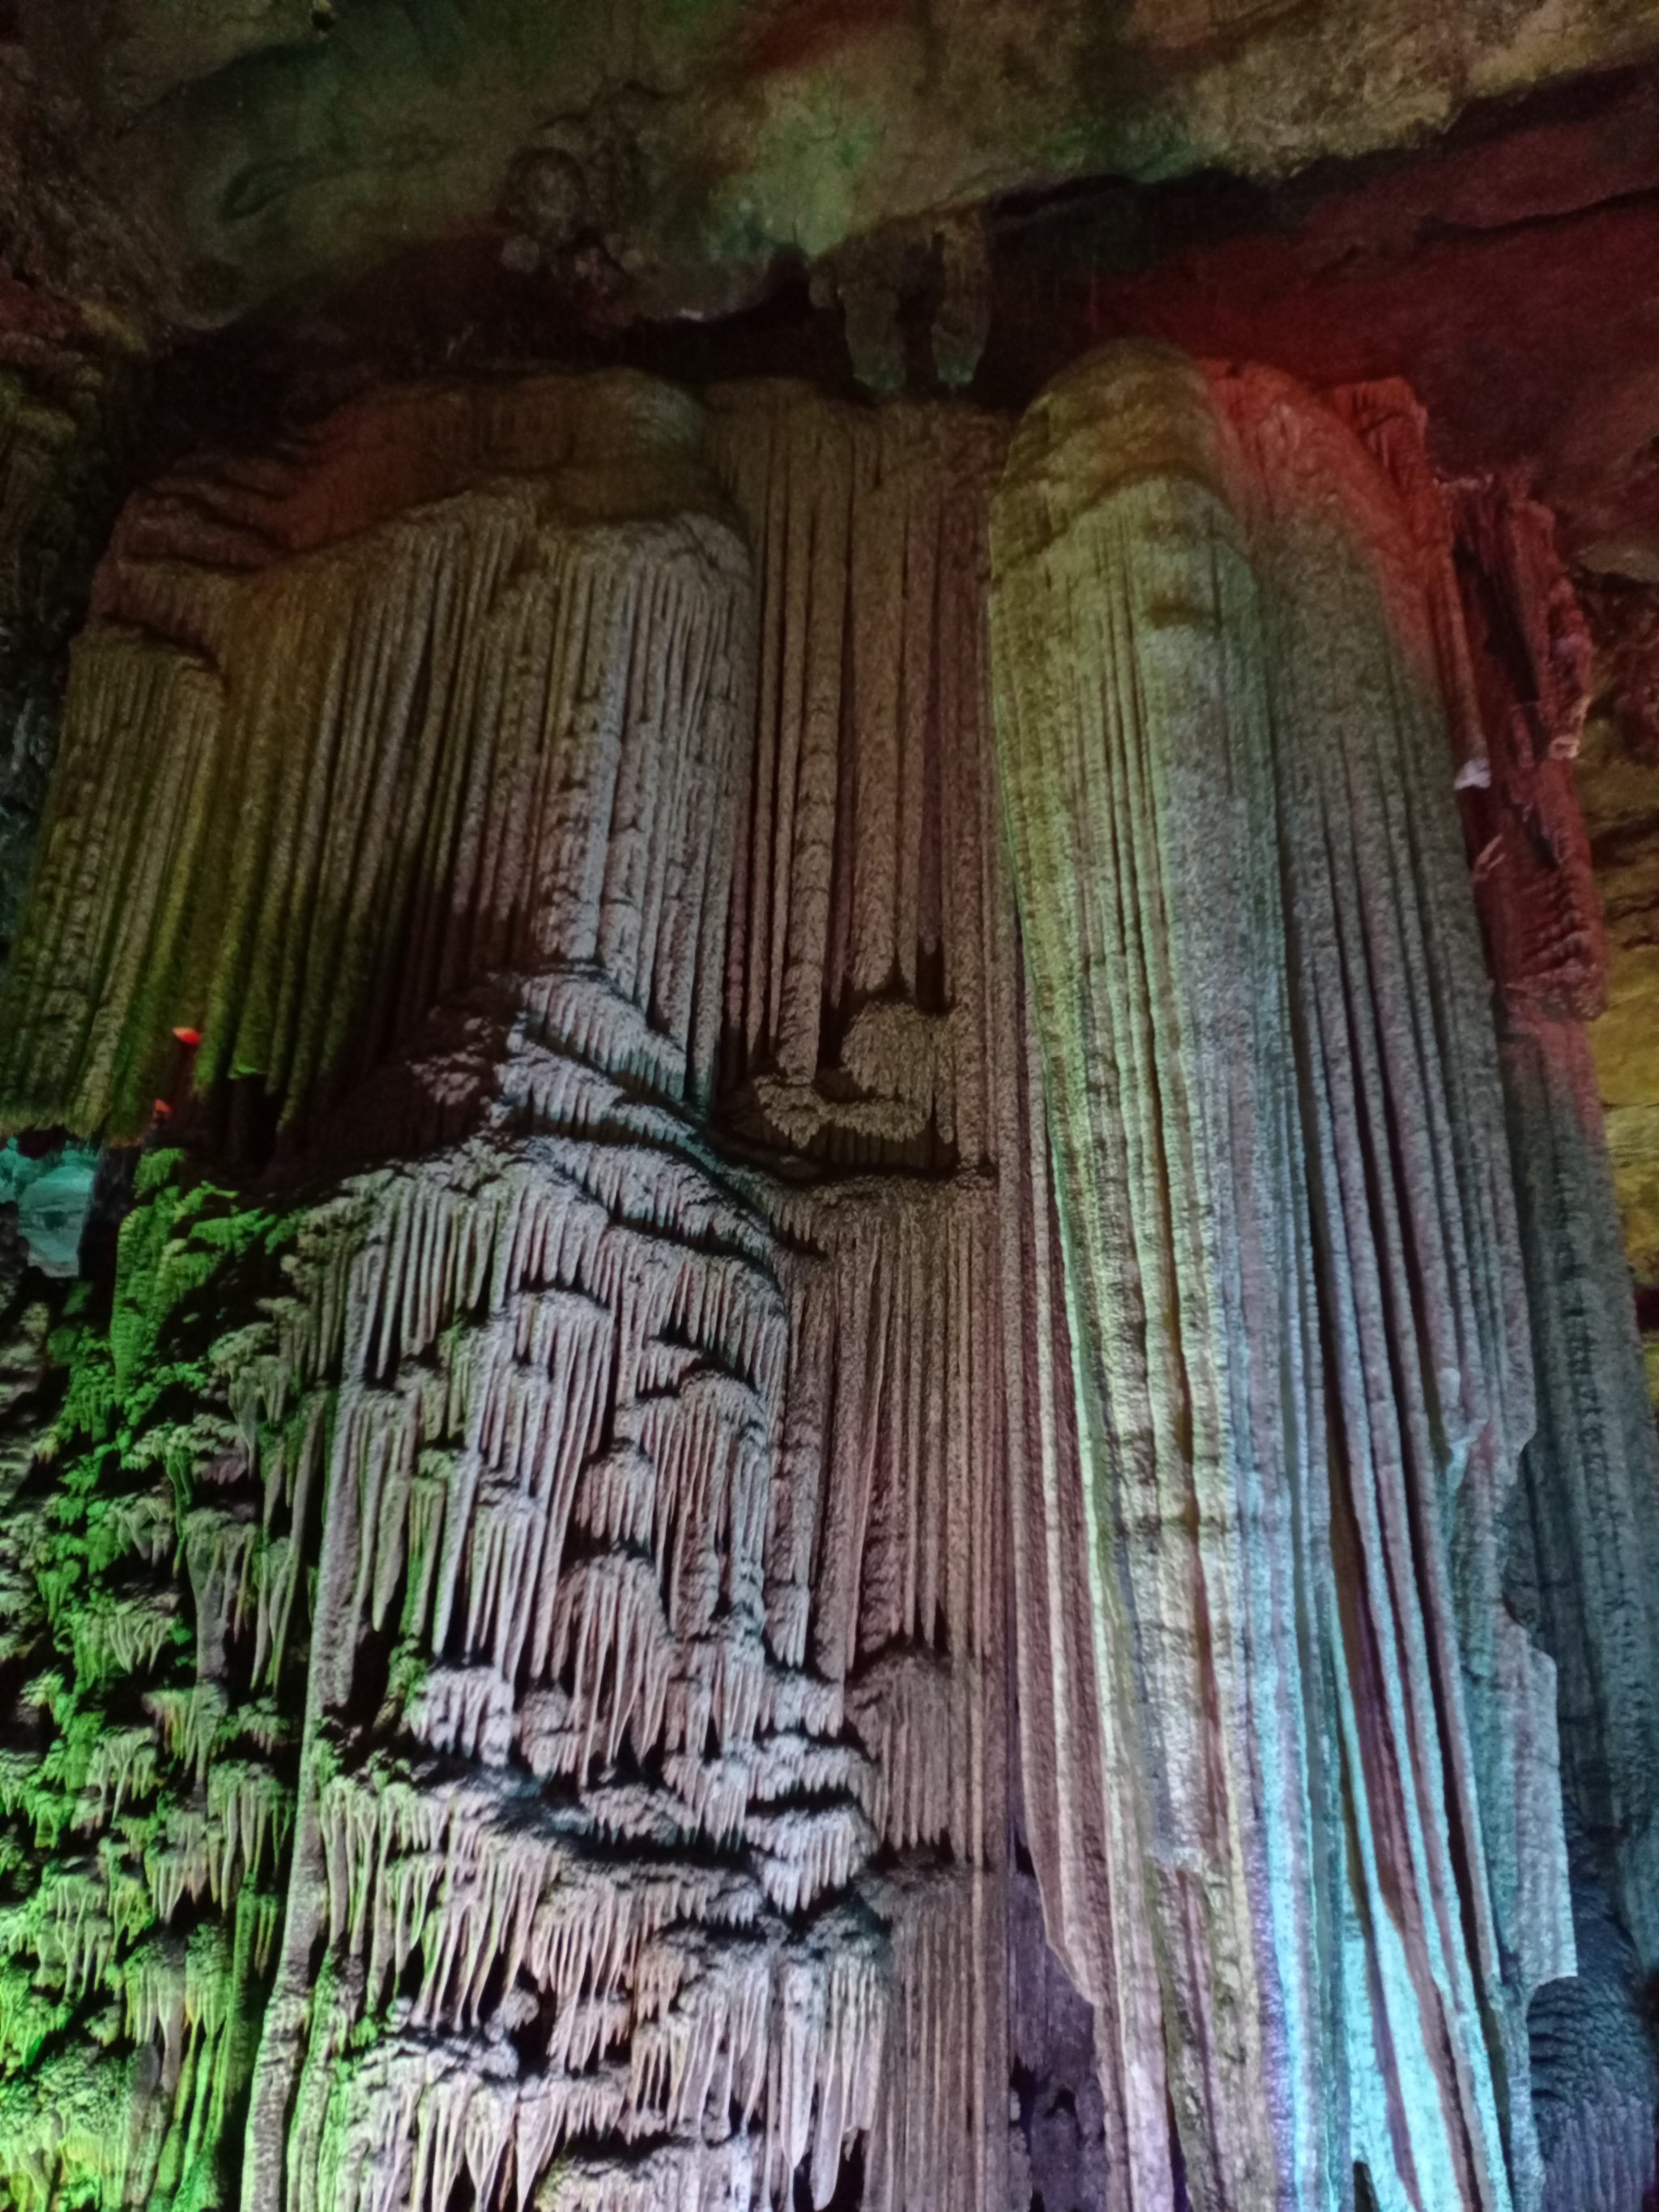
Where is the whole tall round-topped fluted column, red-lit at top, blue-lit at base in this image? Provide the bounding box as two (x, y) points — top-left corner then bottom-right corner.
(993, 347), (1571, 2212)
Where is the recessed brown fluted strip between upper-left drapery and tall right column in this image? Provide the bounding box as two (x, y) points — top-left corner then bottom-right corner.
(710, 382), (1011, 1168)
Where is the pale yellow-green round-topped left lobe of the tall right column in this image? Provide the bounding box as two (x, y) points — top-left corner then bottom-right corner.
(993, 354), (1318, 2206)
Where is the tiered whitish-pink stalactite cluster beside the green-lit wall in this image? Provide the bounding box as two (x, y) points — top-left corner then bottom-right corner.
(228, 1061), (887, 2208)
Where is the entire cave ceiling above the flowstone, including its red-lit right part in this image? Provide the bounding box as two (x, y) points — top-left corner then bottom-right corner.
(16, 0), (1659, 575)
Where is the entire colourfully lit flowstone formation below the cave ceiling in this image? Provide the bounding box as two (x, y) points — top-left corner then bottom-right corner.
(0, 347), (1659, 2212)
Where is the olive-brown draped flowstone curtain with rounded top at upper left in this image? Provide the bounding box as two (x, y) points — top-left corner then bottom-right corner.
(0, 376), (752, 1135)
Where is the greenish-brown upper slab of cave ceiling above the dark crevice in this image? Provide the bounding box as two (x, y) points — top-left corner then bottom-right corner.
(0, 0), (1659, 340)
